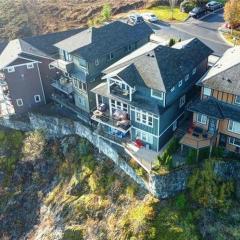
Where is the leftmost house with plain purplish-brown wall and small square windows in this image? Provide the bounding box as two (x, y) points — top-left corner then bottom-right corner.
(0, 29), (83, 116)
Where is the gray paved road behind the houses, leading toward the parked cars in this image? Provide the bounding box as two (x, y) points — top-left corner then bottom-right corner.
(150, 10), (230, 56)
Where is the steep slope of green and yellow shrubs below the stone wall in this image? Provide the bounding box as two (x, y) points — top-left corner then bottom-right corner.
(0, 130), (240, 240)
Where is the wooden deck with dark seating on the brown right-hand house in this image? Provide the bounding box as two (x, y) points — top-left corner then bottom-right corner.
(180, 127), (215, 150)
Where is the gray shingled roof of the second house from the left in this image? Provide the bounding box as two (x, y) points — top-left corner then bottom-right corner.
(55, 21), (153, 60)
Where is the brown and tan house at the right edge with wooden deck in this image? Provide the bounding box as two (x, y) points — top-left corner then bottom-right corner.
(181, 47), (240, 152)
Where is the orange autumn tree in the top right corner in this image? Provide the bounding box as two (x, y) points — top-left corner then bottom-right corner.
(224, 0), (240, 29)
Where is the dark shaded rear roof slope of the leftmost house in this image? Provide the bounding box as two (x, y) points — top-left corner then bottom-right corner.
(23, 28), (83, 56)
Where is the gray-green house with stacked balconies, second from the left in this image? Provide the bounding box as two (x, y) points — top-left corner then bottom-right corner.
(50, 21), (153, 121)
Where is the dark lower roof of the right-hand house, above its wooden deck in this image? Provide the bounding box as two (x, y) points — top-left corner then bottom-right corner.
(188, 98), (240, 122)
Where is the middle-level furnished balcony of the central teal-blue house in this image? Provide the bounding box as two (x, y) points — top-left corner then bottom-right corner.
(91, 104), (131, 133)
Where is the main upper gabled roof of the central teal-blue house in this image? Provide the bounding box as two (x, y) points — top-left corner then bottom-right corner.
(103, 39), (213, 92)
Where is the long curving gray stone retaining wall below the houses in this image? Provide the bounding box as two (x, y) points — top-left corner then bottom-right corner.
(0, 113), (240, 198)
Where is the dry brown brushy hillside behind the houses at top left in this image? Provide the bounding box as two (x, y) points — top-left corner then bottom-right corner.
(0, 0), (152, 39)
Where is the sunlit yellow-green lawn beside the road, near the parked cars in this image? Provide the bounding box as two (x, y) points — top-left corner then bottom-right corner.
(139, 6), (188, 22)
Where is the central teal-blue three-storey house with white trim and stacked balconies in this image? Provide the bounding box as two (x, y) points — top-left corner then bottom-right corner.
(92, 39), (212, 151)
